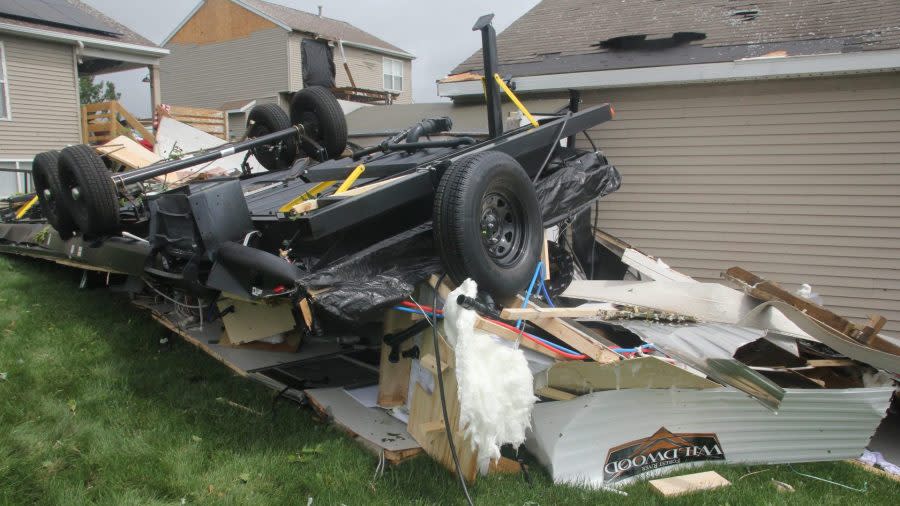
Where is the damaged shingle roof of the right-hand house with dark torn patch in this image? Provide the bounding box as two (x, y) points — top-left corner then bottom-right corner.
(451, 0), (900, 76)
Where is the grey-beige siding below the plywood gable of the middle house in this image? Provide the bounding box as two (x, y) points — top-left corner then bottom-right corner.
(160, 28), (290, 109)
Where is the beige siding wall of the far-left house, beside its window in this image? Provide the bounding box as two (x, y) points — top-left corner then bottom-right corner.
(0, 35), (81, 159)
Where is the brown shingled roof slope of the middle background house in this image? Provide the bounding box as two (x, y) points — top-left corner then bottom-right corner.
(237, 0), (413, 59)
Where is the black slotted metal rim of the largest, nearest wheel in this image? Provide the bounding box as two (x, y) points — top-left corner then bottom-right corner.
(480, 191), (525, 266)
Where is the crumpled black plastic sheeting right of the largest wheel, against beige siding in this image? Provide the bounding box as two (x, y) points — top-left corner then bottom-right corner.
(534, 147), (622, 226)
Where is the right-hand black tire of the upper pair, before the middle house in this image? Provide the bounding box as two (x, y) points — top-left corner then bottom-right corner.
(291, 86), (347, 158)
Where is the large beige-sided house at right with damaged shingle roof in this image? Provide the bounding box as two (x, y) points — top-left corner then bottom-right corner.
(439, 0), (900, 332)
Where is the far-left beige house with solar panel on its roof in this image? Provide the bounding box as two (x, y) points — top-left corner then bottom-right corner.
(0, 0), (168, 196)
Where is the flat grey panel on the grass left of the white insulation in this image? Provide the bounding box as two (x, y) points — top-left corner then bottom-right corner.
(305, 388), (422, 464)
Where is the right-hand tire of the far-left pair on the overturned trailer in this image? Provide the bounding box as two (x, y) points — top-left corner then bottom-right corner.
(58, 144), (121, 238)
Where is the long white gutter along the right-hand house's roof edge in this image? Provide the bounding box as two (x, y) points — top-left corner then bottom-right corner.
(438, 49), (900, 97)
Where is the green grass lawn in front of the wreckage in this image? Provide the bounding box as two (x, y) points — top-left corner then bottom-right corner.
(0, 255), (900, 506)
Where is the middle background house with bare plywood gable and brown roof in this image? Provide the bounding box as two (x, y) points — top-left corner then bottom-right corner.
(162, 0), (414, 138)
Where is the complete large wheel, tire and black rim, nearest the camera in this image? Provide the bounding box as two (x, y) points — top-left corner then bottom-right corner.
(433, 151), (543, 297)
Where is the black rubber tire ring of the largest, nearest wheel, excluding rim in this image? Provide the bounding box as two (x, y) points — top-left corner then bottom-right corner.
(433, 151), (543, 297)
